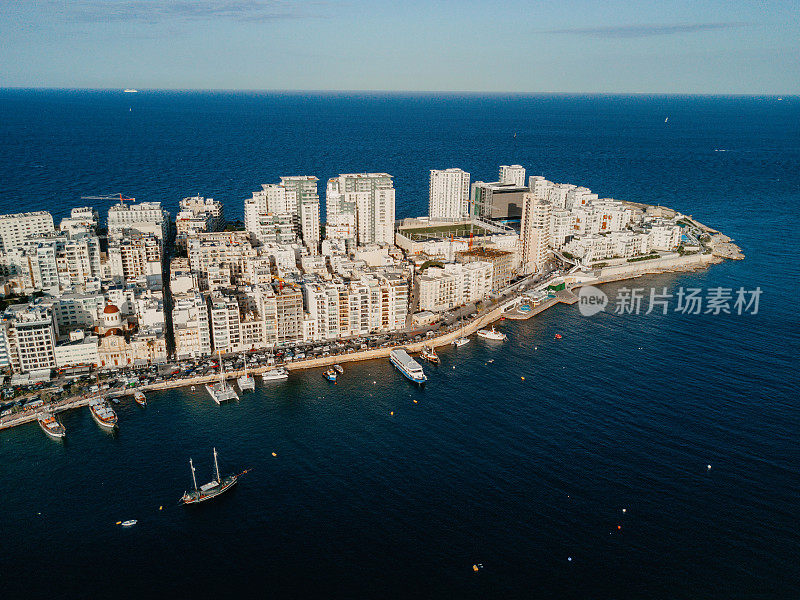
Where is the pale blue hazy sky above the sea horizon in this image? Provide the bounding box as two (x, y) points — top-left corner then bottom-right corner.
(0, 0), (800, 95)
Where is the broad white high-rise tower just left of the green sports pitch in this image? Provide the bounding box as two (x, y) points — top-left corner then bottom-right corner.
(325, 173), (395, 245)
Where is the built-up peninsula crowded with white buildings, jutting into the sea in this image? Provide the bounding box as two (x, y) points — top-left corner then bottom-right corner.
(0, 165), (743, 429)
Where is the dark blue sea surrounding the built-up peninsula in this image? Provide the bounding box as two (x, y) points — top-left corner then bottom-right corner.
(0, 90), (800, 600)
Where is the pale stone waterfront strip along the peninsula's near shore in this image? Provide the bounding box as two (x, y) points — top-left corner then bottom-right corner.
(0, 246), (724, 431)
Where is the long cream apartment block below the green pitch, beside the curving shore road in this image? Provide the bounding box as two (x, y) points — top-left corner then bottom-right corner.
(416, 261), (494, 312)
